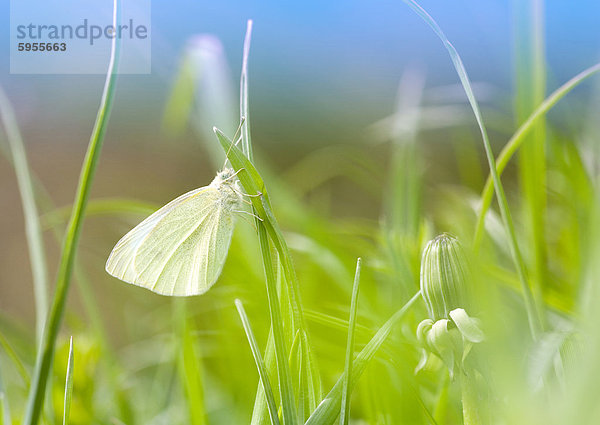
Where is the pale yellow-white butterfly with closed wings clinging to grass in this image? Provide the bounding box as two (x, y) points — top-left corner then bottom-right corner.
(106, 168), (243, 296)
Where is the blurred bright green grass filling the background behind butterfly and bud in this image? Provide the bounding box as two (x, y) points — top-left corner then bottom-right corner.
(0, 0), (600, 425)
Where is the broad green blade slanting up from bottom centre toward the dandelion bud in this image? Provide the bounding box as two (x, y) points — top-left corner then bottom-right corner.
(306, 291), (421, 425)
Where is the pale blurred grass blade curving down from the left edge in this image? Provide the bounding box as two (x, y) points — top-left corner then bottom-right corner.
(0, 88), (48, 341)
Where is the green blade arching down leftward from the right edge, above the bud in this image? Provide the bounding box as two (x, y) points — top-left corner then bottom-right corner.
(474, 63), (600, 248)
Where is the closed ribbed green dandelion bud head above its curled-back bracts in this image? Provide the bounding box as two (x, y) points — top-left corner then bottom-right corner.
(421, 233), (470, 321)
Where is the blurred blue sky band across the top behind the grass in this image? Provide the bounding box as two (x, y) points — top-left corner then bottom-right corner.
(0, 0), (600, 149)
